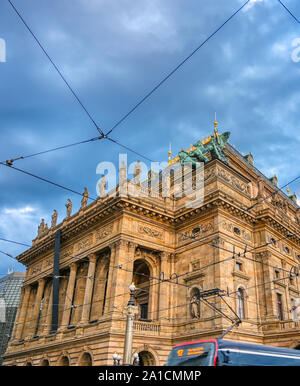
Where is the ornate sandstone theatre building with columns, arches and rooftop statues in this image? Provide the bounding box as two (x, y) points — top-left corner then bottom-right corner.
(4, 125), (300, 366)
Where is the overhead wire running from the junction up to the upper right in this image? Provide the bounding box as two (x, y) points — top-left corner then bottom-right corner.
(105, 0), (250, 137)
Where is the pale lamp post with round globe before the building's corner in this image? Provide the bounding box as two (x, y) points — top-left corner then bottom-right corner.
(123, 283), (138, 366)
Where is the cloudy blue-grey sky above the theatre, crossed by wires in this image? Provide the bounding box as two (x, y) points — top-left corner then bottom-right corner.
(0, 0), (300, 277)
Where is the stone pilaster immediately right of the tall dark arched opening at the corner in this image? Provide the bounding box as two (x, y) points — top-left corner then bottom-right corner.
(159, 252), (170, 318)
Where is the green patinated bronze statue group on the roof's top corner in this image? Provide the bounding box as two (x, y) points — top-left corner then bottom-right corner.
(178, 121), (230, 166)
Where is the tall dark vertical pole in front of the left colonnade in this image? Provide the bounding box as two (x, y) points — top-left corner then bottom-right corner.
(50, 229), (61, 334)
